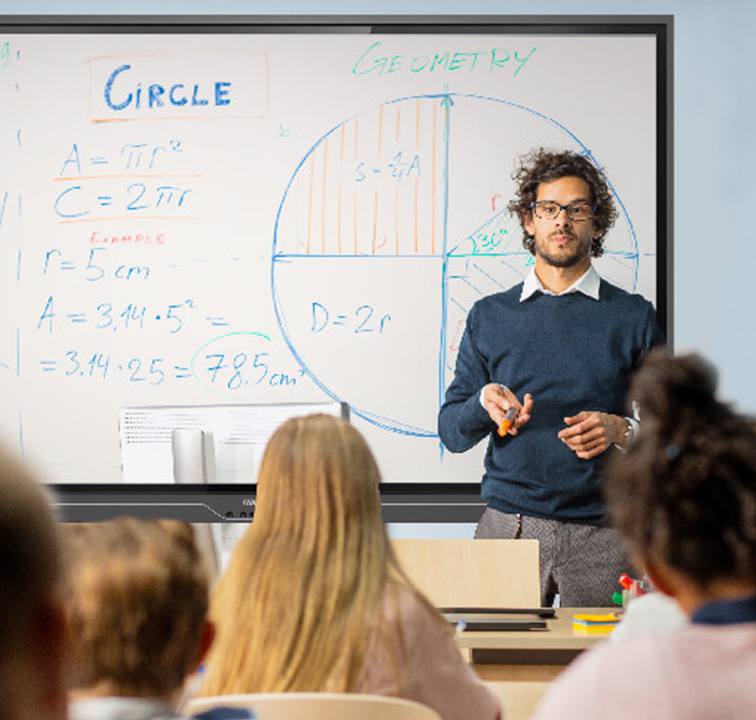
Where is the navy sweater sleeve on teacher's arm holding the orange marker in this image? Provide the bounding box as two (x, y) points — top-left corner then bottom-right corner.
(438, 307), (496, 452)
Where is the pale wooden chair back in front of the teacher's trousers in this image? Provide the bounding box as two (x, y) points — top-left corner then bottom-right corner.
(391, 538), (541, 608)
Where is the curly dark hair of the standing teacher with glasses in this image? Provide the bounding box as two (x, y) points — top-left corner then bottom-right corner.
(507, 148), (619, 257)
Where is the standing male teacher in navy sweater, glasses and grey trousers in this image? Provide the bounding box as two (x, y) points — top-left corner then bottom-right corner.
(438, 149), (664, 607)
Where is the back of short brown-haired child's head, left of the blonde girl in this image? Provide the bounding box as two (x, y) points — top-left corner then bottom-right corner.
(62, 518), (212, 702)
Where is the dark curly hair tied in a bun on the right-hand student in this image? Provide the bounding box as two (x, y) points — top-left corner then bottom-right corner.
(605, 349), (756, 590)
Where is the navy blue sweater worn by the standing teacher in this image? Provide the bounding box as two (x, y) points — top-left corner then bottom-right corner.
(438, 280), (664, 524)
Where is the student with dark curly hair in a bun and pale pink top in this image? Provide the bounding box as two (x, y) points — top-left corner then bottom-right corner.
(534, 351), (756, 720)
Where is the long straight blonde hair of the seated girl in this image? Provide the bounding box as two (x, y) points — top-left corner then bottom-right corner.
(200, 415), (434, 695)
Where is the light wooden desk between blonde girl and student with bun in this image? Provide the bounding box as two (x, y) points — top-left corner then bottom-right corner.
(456, 608), (616, 720)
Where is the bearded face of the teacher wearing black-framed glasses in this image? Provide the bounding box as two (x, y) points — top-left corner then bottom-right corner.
(523, 176), (598, 268)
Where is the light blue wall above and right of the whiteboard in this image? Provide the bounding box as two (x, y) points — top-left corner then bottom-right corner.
(0, 0), (756, 532)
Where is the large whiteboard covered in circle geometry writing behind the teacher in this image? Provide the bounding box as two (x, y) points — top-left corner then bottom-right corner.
(0, 17), (671, 484)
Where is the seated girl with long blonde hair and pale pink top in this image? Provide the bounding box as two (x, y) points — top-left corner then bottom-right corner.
(200, 415), (501, 720)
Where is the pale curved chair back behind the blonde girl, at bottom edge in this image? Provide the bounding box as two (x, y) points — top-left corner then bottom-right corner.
(184, 693), (441, 720)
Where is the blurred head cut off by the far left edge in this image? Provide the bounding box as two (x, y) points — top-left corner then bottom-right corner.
(0, 449), (66, 720)
